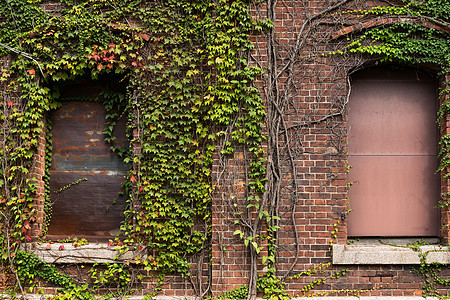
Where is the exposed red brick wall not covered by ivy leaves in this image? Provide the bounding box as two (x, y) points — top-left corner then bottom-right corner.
(5, 0), (450, 296)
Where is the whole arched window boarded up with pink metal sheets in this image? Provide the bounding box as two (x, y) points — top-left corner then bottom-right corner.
(348, 69), (440, 236)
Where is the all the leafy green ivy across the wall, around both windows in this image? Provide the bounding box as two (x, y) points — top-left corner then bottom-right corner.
(0, 0), (450, 299)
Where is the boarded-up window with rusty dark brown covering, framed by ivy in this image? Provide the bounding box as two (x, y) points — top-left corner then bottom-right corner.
(47, 82), (128, 241)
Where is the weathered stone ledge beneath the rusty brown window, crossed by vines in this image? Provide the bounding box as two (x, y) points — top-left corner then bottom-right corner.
(24, 243), (144, 264)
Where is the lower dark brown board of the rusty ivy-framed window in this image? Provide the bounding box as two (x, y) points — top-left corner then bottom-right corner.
(48, 171), (125, 239)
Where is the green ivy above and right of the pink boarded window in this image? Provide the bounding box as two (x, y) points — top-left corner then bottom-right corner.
(347, 0), (450, 298)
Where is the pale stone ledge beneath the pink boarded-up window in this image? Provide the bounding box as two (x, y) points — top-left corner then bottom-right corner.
(333, 243), (450, 265)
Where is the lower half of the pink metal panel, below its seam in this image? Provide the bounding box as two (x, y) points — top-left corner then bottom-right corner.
(348, 156), (439, 236)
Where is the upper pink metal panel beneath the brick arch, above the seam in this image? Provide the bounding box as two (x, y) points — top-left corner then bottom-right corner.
(349, 71), (437, 155)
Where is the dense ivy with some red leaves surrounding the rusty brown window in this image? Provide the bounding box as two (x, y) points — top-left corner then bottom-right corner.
(0, 0), (265, 299)
